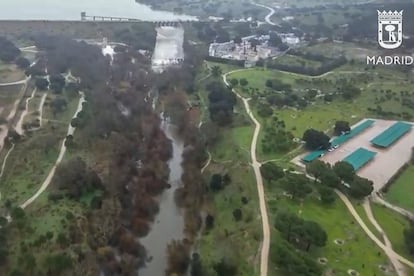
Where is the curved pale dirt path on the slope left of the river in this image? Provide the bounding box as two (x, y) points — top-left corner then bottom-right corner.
(20, 92), (85, 209)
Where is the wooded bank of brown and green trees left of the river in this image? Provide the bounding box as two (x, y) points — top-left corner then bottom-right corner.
(0, 26), (181, 275)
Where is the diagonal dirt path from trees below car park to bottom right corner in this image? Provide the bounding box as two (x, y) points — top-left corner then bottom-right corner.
(335, 190), (414, 276)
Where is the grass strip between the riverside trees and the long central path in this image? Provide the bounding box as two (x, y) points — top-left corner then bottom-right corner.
(197, 154), (262, 276)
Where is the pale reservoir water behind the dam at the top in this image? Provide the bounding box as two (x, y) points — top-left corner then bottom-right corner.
(0, 0), (196, 21)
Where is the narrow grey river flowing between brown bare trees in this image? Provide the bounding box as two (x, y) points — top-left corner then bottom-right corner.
(139, 116), (184, 276)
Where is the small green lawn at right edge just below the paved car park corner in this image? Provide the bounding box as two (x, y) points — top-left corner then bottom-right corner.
(386, 165), (414, 215)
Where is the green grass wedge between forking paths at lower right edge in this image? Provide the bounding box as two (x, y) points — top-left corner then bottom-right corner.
(372, 204), (414, 260)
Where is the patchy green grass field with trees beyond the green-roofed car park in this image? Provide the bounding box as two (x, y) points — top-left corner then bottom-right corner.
(229, 65), (414, 159)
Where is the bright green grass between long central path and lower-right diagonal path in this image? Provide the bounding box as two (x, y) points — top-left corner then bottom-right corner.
(267, 191), (388, 275)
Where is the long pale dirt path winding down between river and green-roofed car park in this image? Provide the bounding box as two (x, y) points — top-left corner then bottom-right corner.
(223, 69), (270, 276)
